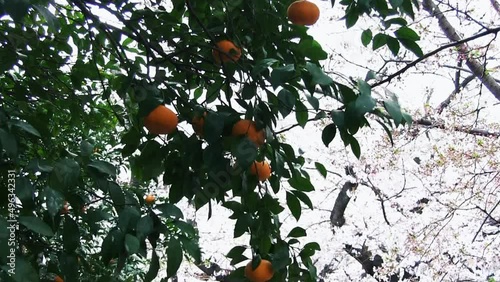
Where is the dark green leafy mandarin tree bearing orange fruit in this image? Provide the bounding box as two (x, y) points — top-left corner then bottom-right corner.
(0, 0), (418, 281)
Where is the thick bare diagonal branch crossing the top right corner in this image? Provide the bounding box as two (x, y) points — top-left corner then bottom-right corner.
(422, 0), (500, 100)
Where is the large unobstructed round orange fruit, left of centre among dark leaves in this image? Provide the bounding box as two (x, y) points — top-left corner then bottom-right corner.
(144, 105), (179, 134)
